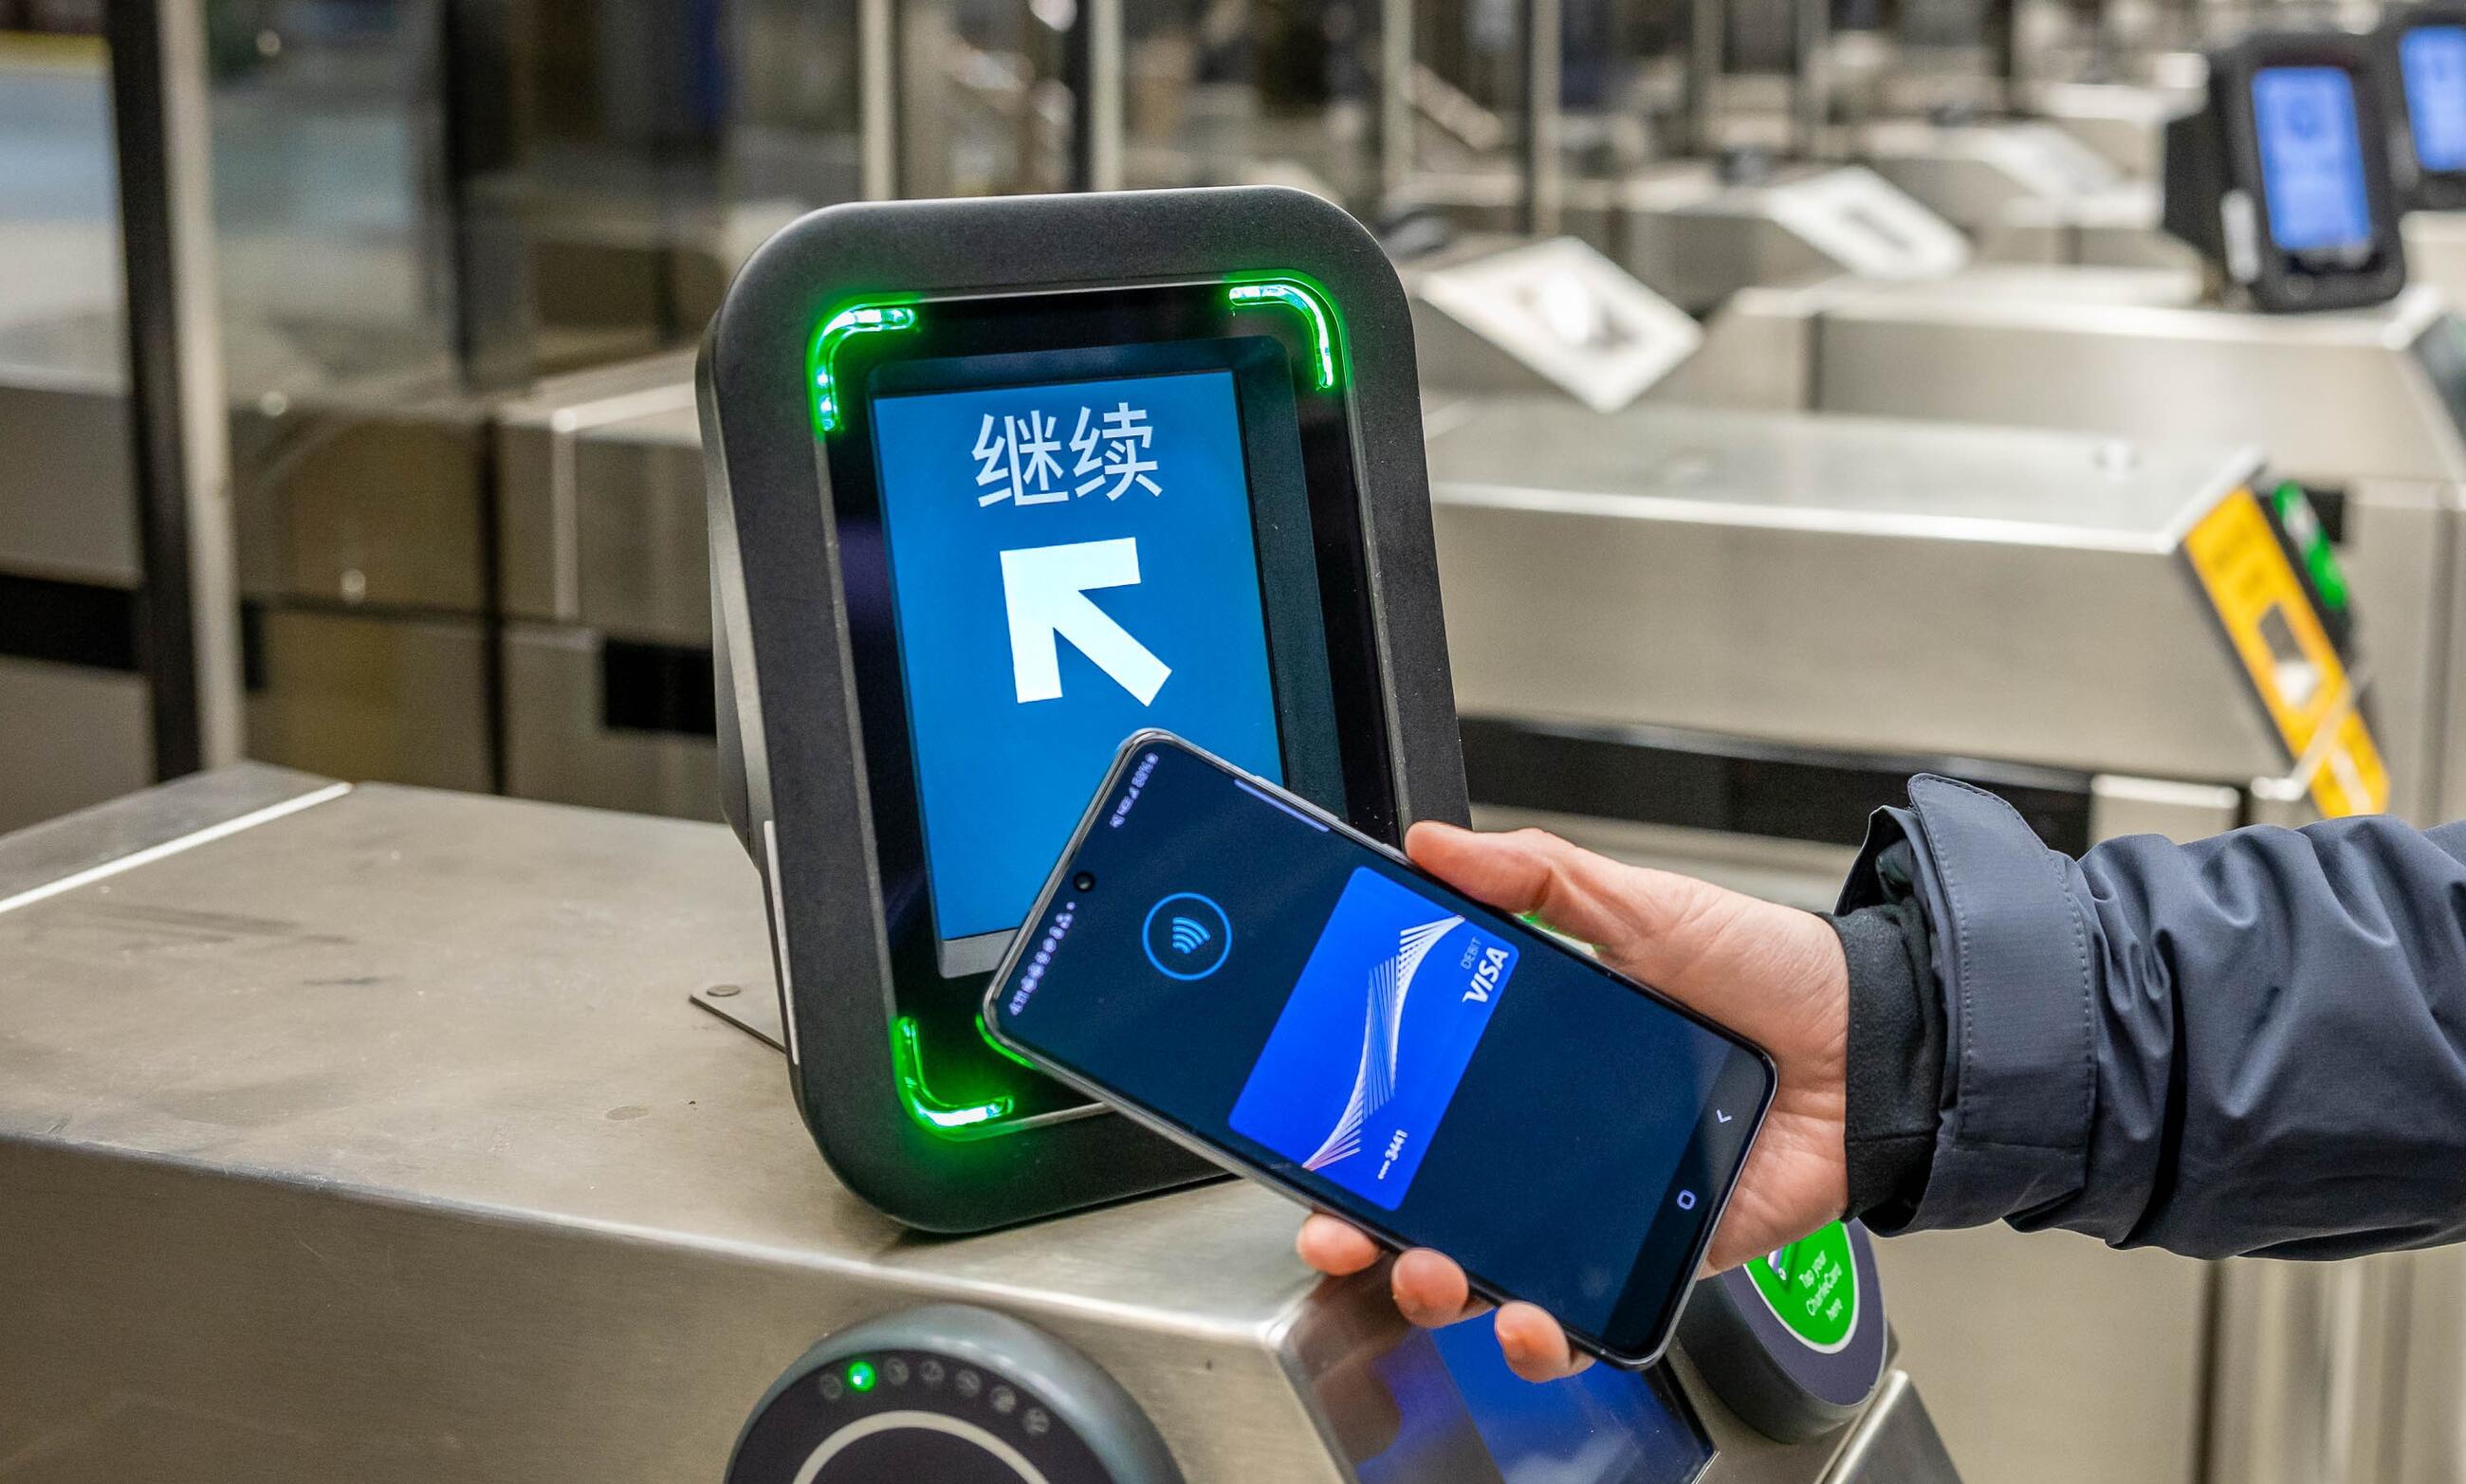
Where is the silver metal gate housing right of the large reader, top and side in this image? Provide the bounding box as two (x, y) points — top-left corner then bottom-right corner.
(1430, 399), (2284, 786)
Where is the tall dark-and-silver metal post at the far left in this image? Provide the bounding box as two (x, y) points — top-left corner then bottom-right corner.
(103, 0), (242, 779)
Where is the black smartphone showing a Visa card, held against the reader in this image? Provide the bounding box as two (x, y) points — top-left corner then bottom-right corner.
(984, 732), (1776, 1365)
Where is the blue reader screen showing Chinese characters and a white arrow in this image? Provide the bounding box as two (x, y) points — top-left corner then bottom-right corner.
(873, 370), (1282, 939)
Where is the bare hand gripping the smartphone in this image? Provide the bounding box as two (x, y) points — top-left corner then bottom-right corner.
(1297, 823), (1850, 1381)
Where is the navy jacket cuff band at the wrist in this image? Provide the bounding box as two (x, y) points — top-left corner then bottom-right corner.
(1842, 777), (2096, 1235)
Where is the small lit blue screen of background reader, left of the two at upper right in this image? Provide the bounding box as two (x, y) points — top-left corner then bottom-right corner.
(2252, 66), (2372, 251)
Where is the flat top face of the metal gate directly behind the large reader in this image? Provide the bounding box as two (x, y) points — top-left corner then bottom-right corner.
(1430, 397), (2261, 552)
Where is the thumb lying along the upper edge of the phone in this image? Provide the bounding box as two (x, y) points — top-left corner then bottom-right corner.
(1406, 821), (1754, 998)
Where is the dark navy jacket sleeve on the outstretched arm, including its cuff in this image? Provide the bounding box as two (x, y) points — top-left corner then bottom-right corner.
(1842, 777), (2466, 1257)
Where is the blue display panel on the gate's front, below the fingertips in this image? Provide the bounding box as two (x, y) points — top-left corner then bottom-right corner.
(1319, 1314), (1711, 1484)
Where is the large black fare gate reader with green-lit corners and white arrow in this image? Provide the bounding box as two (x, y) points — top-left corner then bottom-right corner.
(700, 188), (1464, 1230)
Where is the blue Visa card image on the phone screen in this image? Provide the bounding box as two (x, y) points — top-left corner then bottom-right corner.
(1233, 865), (1517, 1210)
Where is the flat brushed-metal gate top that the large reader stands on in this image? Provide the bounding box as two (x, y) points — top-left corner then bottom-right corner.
(0, 774), (1312, 1336)
